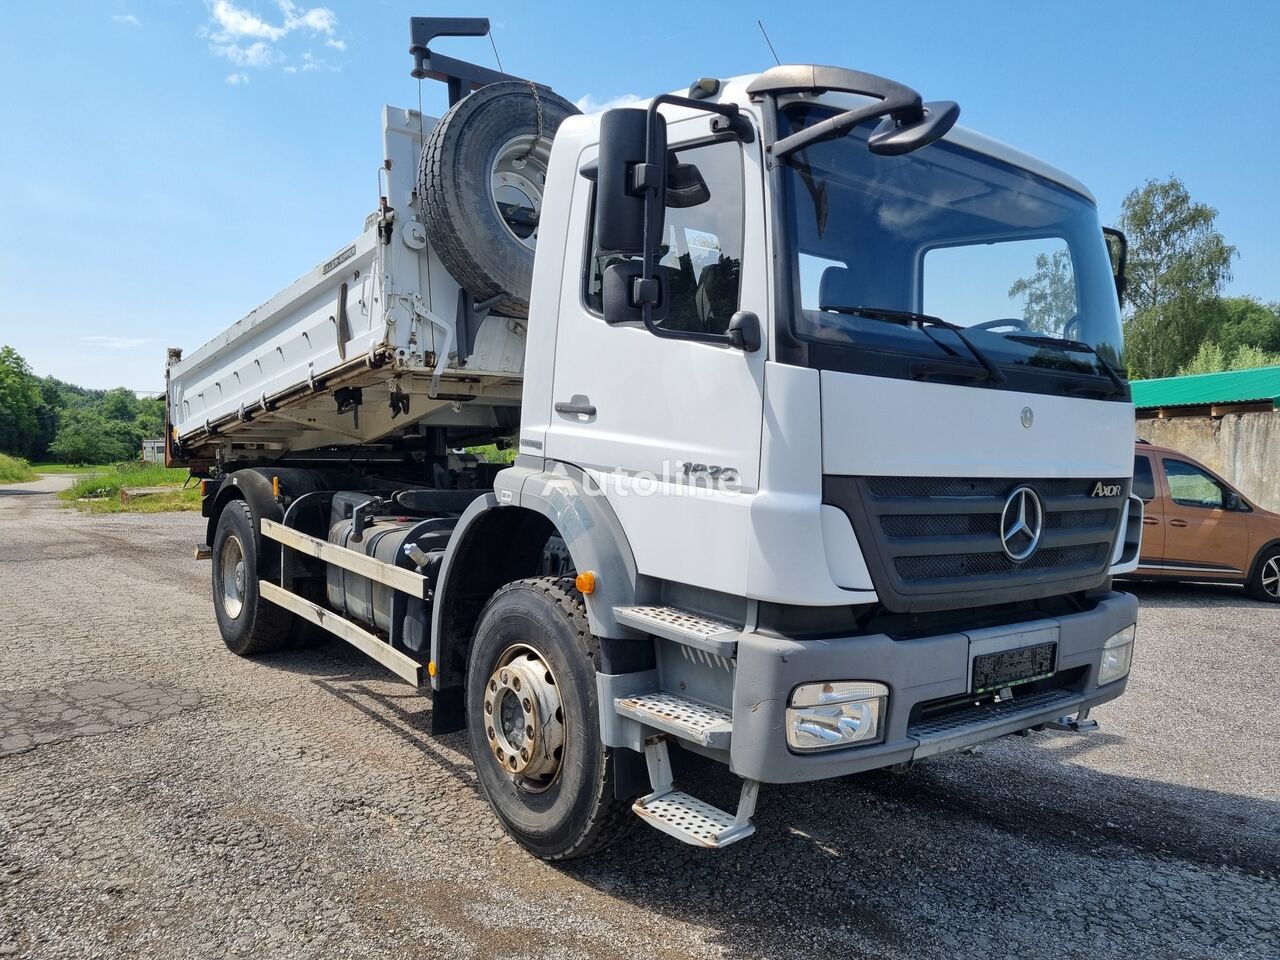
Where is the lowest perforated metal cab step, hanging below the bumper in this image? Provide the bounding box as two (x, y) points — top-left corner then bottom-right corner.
(631, 736), (760, 849)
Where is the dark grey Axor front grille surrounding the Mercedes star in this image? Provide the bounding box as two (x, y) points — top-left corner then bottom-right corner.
(823, 476), (1129, 611)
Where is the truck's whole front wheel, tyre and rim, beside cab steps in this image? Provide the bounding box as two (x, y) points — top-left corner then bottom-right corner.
(466, 577), (635, 860)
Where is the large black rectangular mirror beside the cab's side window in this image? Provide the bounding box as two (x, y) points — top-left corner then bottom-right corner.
(595, 108), (667, 256)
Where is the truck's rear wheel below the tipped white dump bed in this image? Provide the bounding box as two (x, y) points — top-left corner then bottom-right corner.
(212, 500), (294, 657)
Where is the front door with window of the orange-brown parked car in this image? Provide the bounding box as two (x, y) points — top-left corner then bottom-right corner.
(1161, 457), (1249, 580)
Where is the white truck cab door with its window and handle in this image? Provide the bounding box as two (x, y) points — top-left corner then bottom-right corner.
(545, 116), (771, 596)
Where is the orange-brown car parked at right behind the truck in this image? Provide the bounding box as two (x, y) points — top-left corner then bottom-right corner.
(1133, 440), (1280, 603)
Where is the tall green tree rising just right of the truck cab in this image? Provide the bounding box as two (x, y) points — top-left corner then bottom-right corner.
(1120, 177), (1235, 378)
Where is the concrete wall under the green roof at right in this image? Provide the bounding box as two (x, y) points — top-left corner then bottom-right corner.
(1137, 411), (1280, 512)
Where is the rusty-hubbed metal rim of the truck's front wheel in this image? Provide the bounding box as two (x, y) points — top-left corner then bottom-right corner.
(484, 644), (564, 792)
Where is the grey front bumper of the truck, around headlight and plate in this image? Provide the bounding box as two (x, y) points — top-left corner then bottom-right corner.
(730, 593), (1138, 783)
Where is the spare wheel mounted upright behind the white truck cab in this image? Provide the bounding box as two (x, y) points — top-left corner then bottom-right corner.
(419, 81), (580, 316)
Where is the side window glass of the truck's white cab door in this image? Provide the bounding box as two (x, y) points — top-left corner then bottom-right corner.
(585, 141), (744, 334)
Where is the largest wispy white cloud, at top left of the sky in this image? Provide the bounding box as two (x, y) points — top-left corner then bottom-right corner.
(201, 0), (347, 82)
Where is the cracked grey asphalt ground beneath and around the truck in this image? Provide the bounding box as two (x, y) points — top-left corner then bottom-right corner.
(0, 480), (1280, 960)
